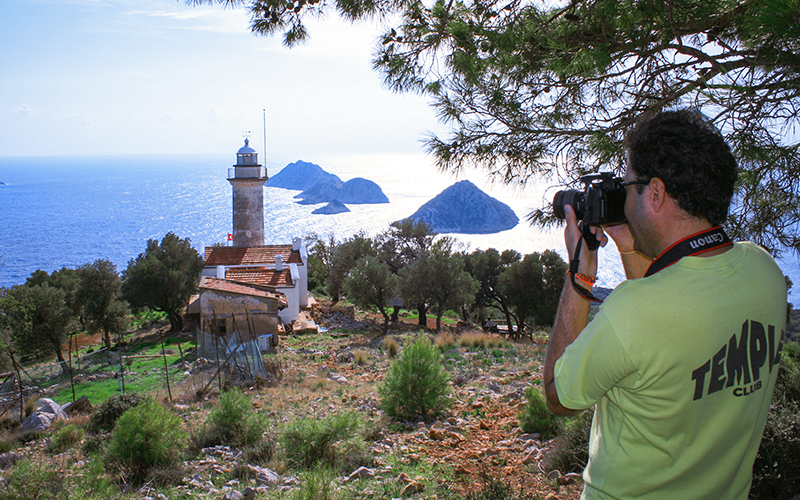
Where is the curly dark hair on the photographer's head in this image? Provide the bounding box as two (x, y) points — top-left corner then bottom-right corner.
(623, 109), (737, 225)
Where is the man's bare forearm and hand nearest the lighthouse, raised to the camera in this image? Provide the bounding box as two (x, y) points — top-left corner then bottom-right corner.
(542, 205), (608, 416)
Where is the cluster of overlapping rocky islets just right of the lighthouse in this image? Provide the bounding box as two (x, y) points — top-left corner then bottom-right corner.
(265, 160), (389, 214)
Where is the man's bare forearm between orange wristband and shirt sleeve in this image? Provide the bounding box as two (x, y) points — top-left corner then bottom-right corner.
(542, 280), (589, 416)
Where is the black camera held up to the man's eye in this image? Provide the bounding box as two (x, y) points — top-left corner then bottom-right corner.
(553, 172), (627, 226)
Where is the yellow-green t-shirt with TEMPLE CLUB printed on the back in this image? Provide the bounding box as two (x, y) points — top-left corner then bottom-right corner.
(555, 243), (786, 500)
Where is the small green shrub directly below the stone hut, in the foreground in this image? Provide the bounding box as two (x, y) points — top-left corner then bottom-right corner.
(191, 388), (265, 451)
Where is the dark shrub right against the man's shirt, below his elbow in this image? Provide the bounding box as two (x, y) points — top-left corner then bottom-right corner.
(542, 408), (594, 474)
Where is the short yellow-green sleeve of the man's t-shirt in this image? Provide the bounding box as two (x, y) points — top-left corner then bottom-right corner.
(554, 309), (636, 410)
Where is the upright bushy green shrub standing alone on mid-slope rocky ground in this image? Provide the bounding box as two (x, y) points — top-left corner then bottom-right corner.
(378, 335), (451, 422)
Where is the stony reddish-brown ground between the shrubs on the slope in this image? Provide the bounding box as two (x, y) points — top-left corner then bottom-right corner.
(0, 305), (582, 500)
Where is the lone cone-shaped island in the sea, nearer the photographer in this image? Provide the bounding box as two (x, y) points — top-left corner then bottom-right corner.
(400, 180), (519, 234)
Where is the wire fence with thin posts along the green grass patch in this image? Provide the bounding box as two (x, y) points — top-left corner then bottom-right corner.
(0, 330), (272, 419)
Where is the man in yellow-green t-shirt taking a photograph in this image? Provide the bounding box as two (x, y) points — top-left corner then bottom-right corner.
(543, 110), (786, 500)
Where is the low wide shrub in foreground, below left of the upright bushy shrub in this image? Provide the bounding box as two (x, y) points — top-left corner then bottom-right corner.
(279, 413), (372, 470)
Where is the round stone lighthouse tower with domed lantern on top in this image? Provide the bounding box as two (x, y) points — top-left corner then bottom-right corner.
(228, 139), (268, 247)
